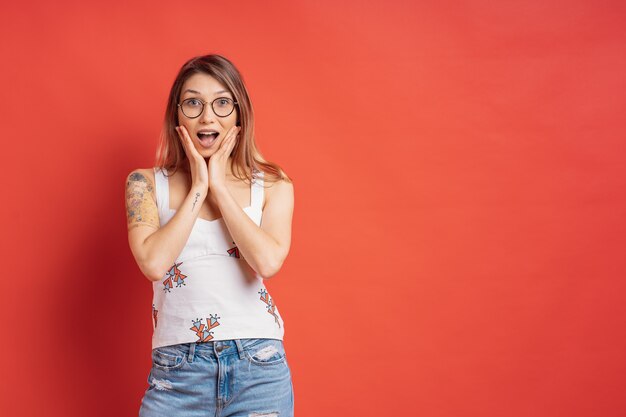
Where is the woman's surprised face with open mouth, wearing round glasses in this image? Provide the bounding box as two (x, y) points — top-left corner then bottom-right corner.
(178, 73), (237, 158)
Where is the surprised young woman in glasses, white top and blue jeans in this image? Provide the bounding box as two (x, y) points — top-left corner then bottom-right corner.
(126, 55), (294, 417)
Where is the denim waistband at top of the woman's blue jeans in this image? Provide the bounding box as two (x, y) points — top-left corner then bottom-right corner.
(154, 338), (283, 362)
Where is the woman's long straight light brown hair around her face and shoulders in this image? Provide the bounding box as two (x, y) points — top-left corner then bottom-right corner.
(156, 54), (292, 182)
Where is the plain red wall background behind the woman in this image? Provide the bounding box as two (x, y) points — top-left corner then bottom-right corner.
(0, 0), (626, 417)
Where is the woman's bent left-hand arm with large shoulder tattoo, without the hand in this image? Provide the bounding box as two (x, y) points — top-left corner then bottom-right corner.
(126, 169), (206, 281)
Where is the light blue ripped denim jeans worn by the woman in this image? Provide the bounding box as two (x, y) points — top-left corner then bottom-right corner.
(139, 339), (294, 417)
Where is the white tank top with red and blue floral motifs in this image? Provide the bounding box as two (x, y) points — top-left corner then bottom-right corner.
(152, 167), (285, 349)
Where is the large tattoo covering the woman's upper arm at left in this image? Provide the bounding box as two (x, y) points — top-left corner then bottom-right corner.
(126, 172), (160, 230)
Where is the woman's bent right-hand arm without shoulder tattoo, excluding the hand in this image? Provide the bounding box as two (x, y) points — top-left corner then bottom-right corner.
(214, 180), (294, 279)
